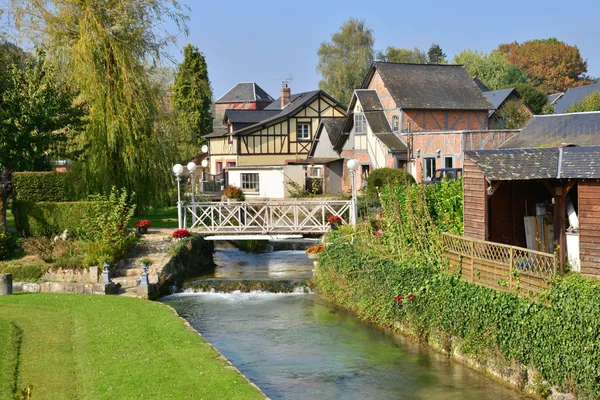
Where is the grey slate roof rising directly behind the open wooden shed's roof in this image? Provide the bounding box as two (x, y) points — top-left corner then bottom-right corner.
(500, 111), (600, 149)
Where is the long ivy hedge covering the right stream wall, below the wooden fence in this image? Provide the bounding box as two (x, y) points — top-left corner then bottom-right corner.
(316, 241), (600, 398)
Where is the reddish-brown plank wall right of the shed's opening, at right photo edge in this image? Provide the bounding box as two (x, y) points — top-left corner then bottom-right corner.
(578, 181), (600, 276)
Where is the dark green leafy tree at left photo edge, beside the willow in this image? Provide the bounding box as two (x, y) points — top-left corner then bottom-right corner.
(0, 46), (84, 231)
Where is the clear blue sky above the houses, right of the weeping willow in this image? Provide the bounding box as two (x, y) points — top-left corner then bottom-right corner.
(171, 0), (600, 98)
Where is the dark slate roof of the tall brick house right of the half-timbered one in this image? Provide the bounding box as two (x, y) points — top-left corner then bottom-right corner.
(362, 62), (494, 110)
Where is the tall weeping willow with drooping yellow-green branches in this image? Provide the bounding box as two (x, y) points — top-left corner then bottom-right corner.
(11, 0), (187, 208)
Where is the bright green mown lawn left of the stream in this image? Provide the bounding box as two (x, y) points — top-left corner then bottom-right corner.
(0, 294), (264, 399)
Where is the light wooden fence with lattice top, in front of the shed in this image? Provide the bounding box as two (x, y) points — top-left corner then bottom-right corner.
(442, 233), (558, 296)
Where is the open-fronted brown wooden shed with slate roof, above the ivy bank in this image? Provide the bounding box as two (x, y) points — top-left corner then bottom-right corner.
(463, 146), (600, 276)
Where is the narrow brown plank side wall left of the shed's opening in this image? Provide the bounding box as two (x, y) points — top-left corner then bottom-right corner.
(463, 155), (488, 240)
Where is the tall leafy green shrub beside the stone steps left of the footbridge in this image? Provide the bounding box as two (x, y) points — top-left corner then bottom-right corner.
(84, 187), (136, 265)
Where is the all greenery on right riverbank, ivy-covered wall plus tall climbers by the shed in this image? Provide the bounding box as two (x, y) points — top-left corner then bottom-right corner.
(316, 182), (600, 398)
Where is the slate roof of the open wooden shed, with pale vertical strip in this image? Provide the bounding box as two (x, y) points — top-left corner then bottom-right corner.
(465, 146), (600, 181)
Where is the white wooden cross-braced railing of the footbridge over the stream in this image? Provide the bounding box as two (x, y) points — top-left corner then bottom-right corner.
(183, 200), (353, 234)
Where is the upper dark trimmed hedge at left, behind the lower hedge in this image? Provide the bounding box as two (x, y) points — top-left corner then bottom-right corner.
(13, 172), (81, 201)
